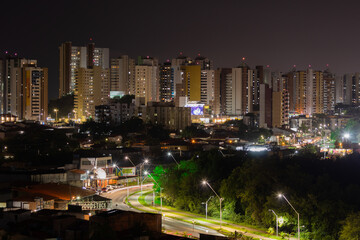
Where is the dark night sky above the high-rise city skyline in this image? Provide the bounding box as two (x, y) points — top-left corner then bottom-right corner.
(0, 0), (360, 98)
